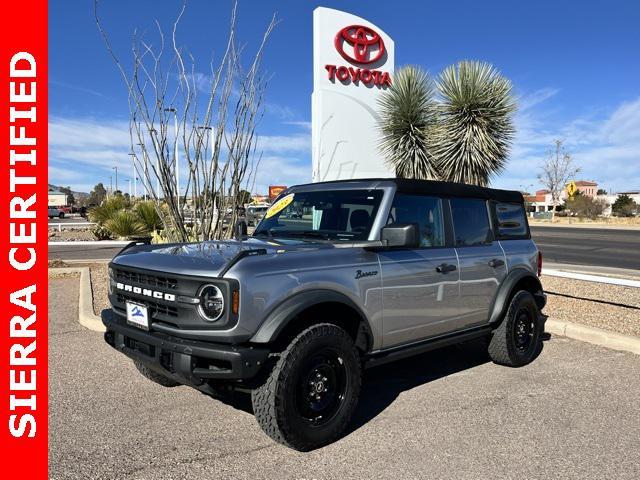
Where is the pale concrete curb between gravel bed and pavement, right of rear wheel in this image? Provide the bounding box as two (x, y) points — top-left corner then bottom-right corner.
(544, 318), (640, 355)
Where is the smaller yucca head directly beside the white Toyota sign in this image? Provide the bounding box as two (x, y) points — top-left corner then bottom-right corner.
(379, 65), (439, 180)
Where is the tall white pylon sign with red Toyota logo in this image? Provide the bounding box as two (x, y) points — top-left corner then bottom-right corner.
(311, 7), (395, 182)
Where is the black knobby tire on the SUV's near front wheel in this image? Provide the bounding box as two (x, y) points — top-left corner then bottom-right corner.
(251, 323), (362, 451)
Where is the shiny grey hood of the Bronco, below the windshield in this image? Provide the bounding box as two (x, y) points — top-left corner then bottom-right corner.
(112, 238), (332, 276)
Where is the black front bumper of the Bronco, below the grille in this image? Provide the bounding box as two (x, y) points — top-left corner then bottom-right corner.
(102, 309), (270, 386)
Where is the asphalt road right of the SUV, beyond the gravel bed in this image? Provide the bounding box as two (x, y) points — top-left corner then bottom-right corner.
(531, 226), (640, 270)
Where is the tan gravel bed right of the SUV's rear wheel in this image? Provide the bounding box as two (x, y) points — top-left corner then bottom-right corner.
(542, 275), (640, 337)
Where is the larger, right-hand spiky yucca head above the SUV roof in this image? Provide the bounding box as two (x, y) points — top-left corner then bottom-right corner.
(433, 61), (516, 185)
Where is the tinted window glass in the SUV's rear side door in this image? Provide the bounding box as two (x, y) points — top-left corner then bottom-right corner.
(451, 198), (493, 247)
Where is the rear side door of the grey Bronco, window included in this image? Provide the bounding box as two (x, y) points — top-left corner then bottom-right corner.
(450, 198), (507, 328)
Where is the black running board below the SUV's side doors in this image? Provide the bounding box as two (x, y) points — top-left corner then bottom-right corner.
(365, 326), (492, 368)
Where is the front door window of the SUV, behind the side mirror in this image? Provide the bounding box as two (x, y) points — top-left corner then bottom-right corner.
(387, 193), (444, 247)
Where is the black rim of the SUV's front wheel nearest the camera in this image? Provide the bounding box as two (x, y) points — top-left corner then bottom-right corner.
(296, 349), (348, 426)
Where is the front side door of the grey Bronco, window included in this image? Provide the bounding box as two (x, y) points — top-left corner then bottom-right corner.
(379, 193), (459, 348)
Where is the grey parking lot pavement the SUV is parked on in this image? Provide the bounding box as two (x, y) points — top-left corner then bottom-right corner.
(49, 279), (640, 480)
